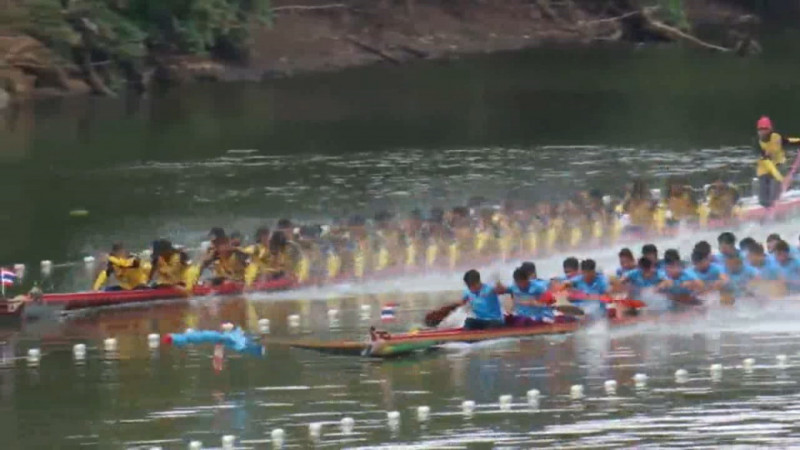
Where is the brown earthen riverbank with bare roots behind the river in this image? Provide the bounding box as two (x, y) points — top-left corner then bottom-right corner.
(0, 0), (764, 100)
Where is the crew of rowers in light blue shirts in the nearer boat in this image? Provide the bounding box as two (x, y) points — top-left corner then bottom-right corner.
(456, 232), (800, 329)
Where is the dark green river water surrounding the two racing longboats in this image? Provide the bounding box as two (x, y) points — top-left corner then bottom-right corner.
(0, 40), (800, 448)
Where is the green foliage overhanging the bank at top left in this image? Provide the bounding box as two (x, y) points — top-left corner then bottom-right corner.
(0, 0), (271, 62)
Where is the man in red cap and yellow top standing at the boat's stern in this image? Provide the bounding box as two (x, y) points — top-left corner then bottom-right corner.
(756, 116), (800, 208)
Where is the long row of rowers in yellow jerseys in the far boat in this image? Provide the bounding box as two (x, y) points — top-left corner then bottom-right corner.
(86, 175), (764, 290)
